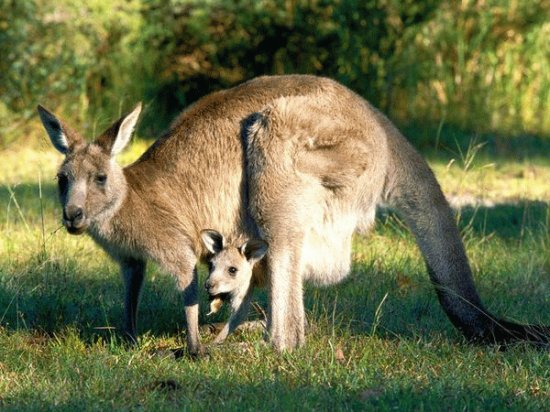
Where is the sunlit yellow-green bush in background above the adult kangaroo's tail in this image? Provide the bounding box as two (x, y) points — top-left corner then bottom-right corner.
(394, 0), (550, 136)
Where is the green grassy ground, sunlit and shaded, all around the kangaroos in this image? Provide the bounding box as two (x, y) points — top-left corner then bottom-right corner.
(0, 136), (550, 410)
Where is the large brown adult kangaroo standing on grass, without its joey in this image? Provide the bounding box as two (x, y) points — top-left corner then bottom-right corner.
(38, 75), (549, 353)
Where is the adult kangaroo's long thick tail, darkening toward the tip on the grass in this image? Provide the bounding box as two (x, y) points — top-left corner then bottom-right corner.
(382, 123), (550, 346)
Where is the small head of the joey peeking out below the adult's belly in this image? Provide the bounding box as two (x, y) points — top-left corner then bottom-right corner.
(201, 230), (267, 300)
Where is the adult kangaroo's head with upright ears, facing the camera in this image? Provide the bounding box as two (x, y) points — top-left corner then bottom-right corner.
(38, 104), (141, 235)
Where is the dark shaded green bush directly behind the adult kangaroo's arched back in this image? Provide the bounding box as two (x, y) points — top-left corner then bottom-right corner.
(135, 0), (439, 134)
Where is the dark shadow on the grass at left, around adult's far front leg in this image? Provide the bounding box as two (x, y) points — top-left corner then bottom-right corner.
(0, 259), (189, 341)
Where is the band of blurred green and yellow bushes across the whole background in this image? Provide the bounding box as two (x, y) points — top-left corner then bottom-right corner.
(0, 0), (550, 143)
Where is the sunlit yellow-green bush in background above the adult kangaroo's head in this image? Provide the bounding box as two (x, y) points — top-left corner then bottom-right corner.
(0, 0), (142, 142)
